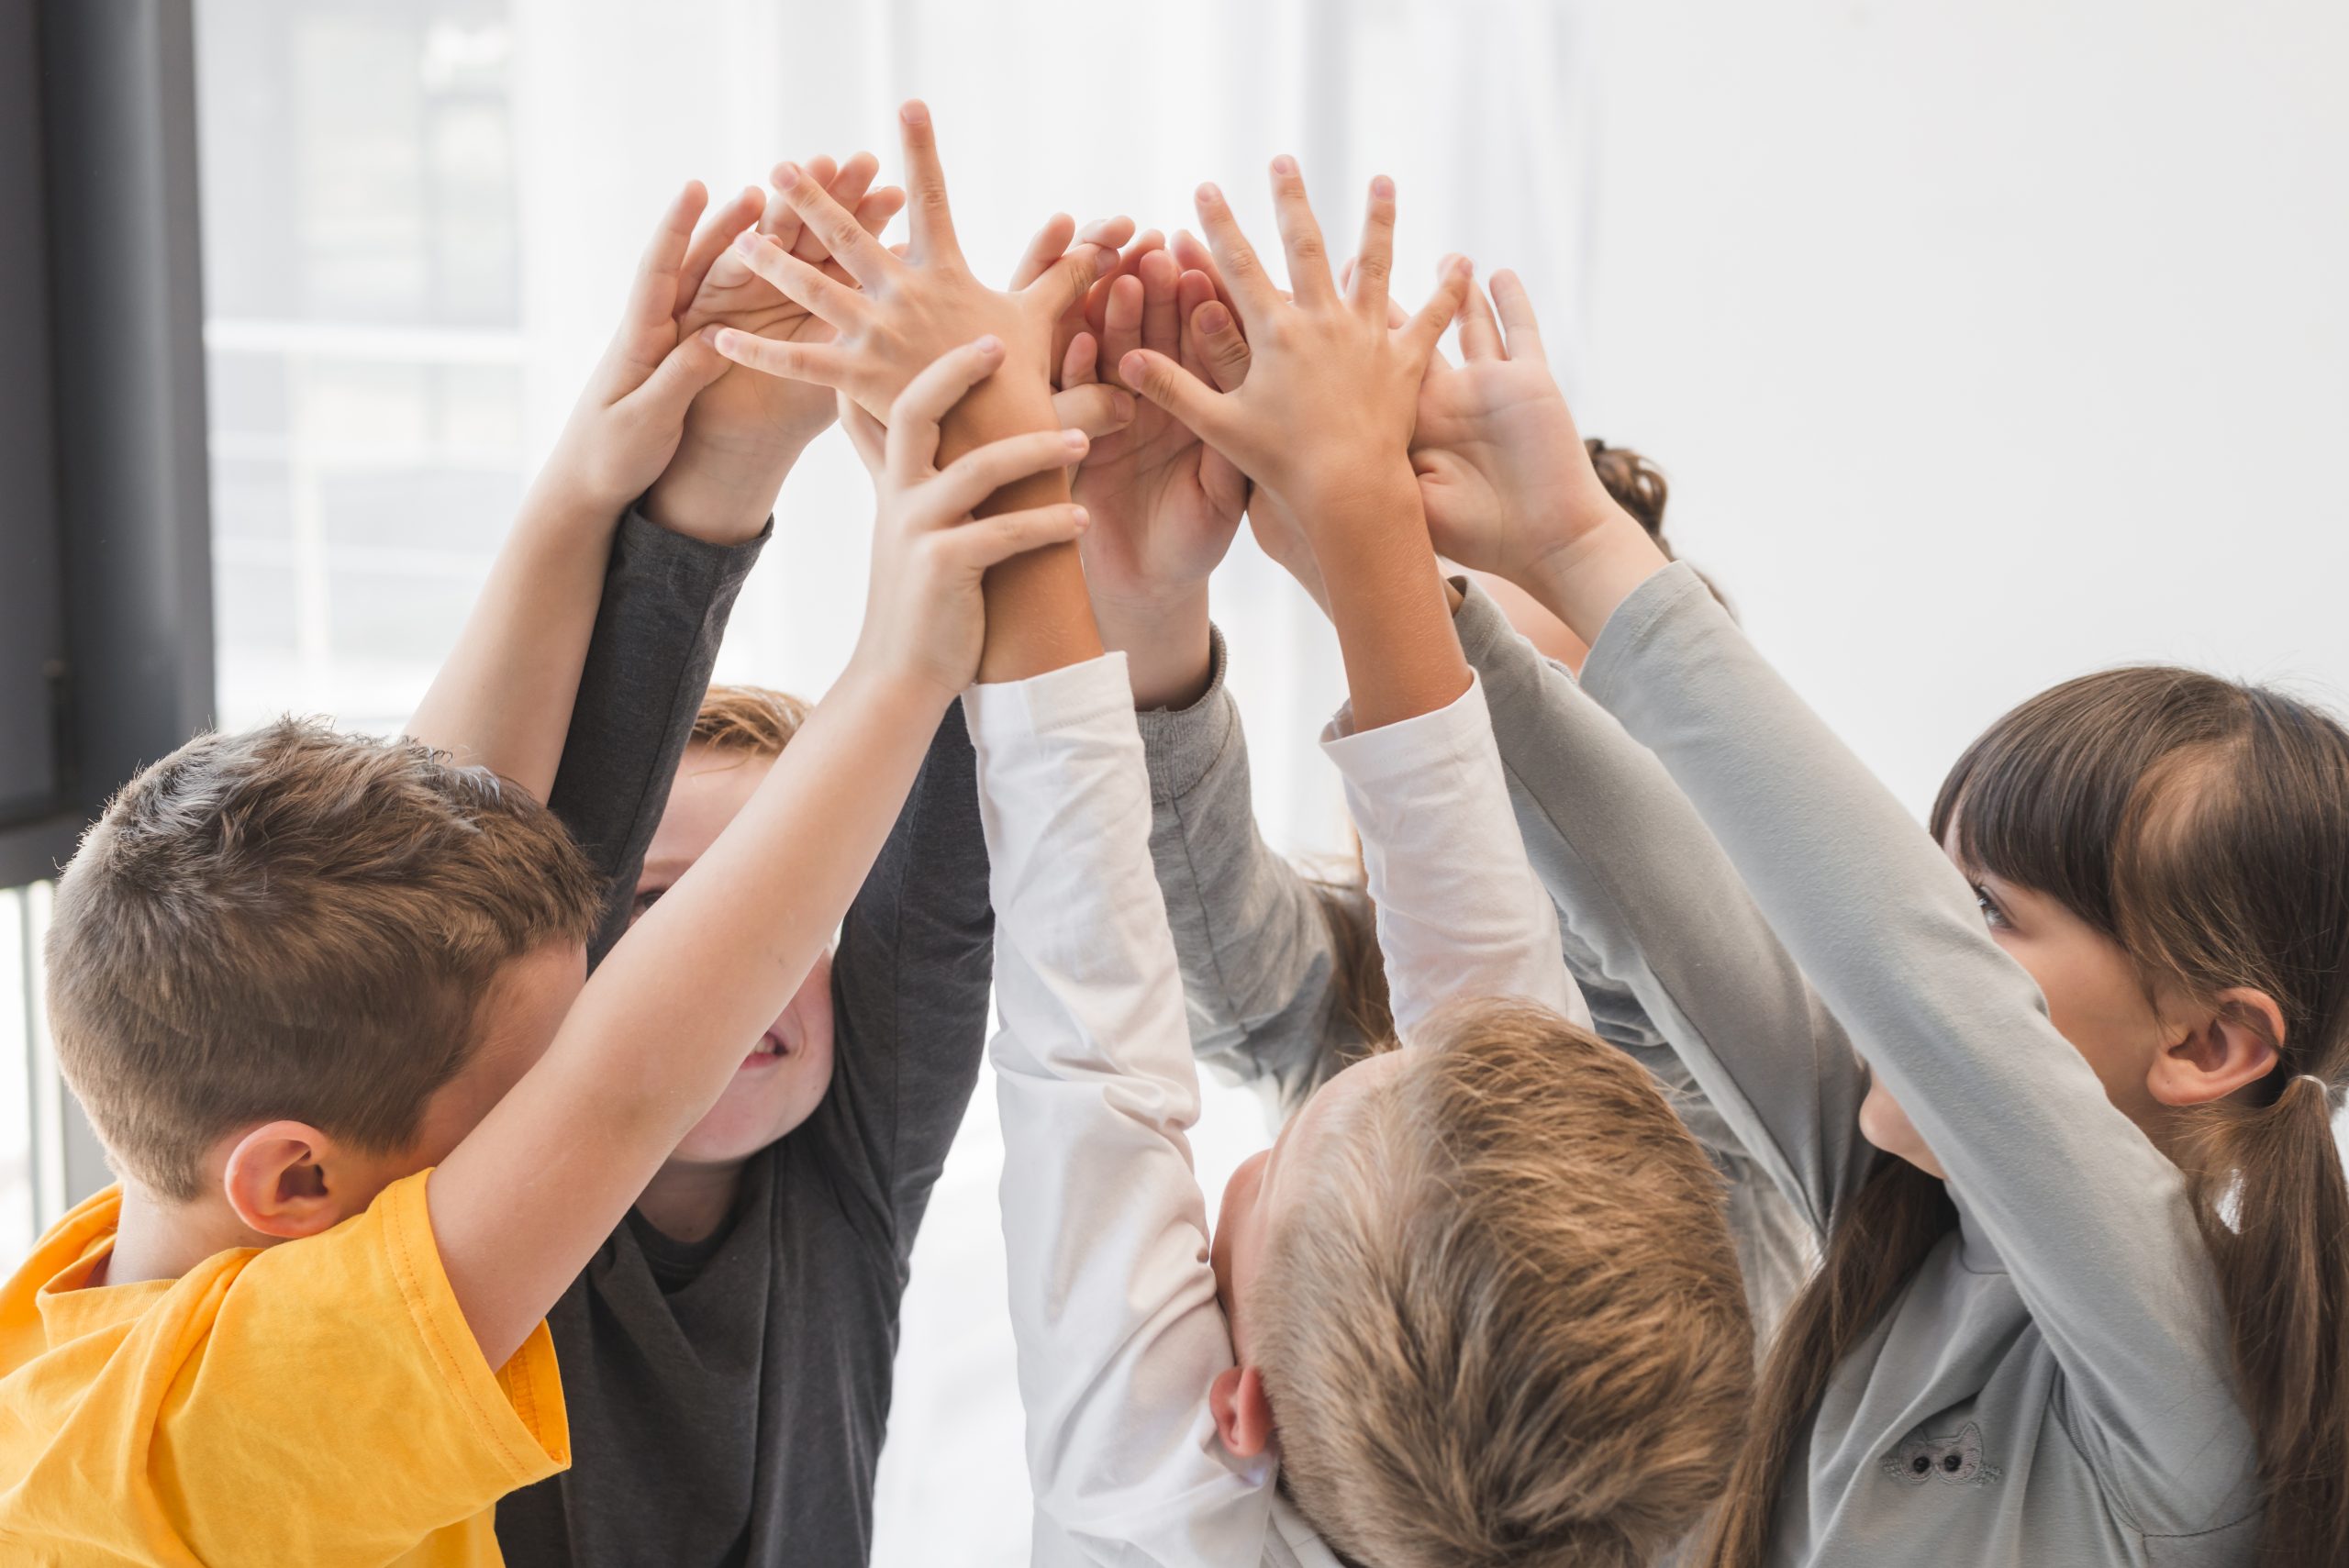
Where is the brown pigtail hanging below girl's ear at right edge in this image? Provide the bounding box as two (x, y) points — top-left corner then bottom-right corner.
(2194, 1073), (2349, 1568)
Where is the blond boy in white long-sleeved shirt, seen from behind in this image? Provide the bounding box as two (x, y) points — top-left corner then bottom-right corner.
(827, 164), (1748, 1565)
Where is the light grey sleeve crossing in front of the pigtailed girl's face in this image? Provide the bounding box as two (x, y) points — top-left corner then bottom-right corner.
(1586, 566), (2248, 1518)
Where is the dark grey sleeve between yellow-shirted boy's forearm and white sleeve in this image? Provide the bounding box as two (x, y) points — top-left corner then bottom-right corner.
(808, 706), (996, 1270)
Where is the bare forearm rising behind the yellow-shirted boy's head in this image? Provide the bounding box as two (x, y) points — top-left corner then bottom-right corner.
(406, 484), (620, 800)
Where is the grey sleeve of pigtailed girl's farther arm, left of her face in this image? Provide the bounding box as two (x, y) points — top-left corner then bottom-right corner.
(1456, 574), (1875, 1235)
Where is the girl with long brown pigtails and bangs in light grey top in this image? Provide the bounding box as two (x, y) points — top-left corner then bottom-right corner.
(1390, 278), (2349, 1568)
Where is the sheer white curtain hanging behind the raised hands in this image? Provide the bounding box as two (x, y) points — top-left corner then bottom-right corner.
(515, 0), (1598, 1565)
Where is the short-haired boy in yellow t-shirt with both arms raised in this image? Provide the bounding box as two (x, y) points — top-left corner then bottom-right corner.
(0, 148), (1099, 1568)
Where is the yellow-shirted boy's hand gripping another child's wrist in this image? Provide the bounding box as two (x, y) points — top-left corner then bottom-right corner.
(841, 336), (1087, 697)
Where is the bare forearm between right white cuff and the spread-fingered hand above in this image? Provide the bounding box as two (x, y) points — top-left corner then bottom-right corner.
(1313, 474), (1468, 730)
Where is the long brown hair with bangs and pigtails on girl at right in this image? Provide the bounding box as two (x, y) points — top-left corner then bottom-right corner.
(1708, 669), (2349, 1568)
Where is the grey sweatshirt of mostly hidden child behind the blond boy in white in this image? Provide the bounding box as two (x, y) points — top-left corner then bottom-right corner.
(1137, 606), (1816, 1331)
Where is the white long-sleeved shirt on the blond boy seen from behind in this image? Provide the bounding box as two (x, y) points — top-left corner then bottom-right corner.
(963, 655), (1588, 1568)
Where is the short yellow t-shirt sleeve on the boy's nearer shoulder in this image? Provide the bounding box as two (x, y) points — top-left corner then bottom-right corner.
(148, 1172), (571, 1563)
